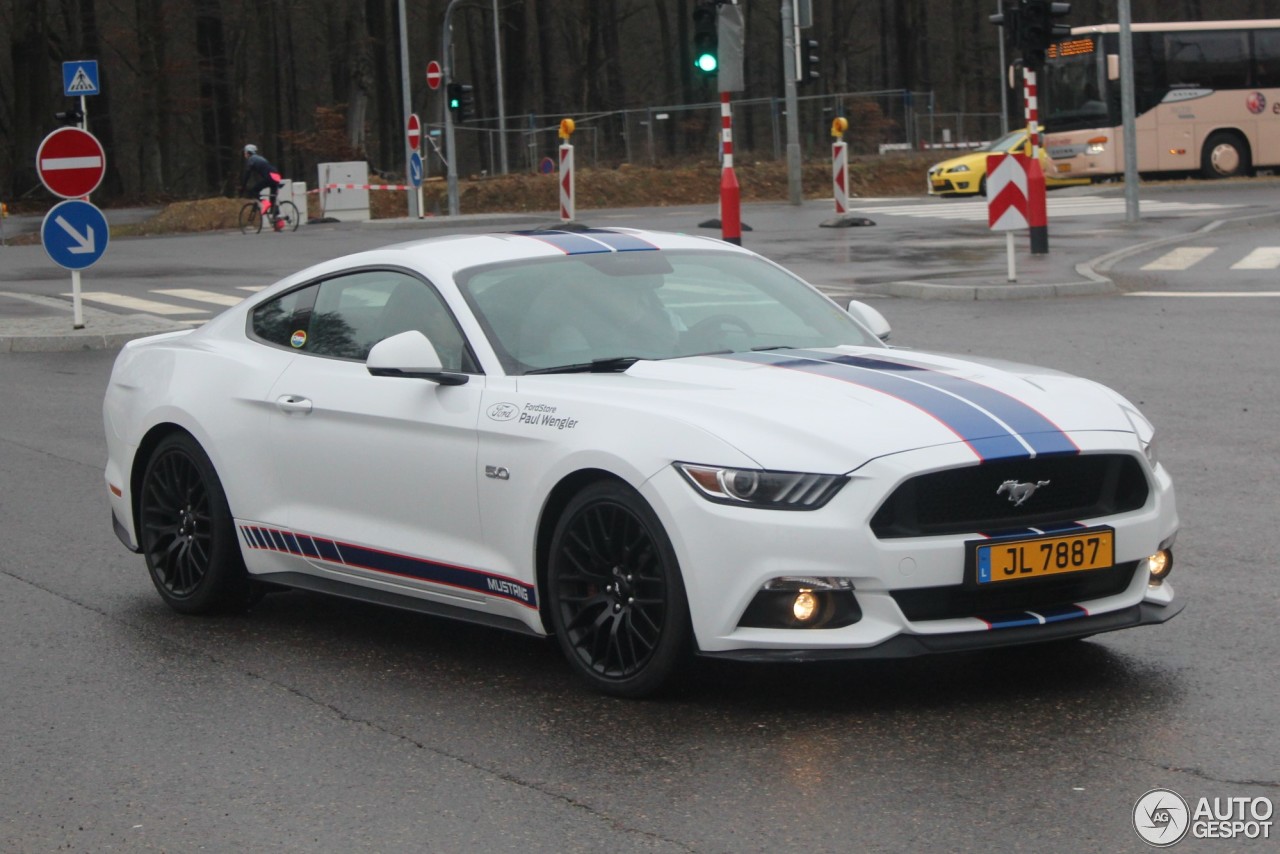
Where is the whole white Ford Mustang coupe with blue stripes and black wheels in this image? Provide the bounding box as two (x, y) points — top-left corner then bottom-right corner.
(104, 229), (1181, 697)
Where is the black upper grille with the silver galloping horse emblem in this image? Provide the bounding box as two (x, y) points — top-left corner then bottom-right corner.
(872, 453), (1149, 539)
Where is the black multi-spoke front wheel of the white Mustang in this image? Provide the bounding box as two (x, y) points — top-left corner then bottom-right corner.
(547, 481), (692, 698)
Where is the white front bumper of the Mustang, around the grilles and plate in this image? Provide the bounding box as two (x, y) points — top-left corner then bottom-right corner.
(644, 434), (1181, 659)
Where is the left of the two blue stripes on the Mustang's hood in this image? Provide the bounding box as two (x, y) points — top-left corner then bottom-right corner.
(724, 353), (1032, 461)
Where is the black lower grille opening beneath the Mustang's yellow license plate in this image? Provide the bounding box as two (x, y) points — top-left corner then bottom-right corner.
(890, 561), (1138, 622)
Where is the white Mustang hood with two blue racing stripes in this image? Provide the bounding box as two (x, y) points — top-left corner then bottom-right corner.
(593, 347), (1134, 471)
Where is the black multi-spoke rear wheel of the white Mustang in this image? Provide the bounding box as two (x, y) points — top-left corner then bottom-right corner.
(138, 433), (253, 613)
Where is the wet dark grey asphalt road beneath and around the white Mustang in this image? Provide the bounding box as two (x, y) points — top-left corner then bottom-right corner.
(0, 185), (1280, 851)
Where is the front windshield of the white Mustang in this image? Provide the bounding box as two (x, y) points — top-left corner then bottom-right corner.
(457, 251), (881, 374)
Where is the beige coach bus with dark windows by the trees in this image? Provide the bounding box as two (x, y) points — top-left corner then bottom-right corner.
(1038, 18), (1280, 179)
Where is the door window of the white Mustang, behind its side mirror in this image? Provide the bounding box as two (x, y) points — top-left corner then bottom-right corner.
(303, 270), (470, 371)
